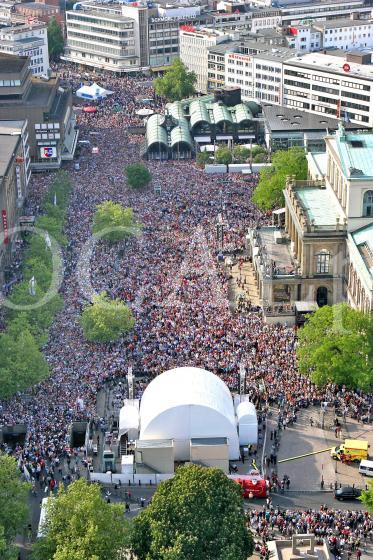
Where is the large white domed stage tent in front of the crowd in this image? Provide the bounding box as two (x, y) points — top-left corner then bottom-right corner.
(140, 367), (240, 461)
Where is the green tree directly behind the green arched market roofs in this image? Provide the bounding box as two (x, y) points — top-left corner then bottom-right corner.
(154, 58), (197, 101)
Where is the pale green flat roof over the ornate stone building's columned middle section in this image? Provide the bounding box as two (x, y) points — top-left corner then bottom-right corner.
(293, 186), (344, 226)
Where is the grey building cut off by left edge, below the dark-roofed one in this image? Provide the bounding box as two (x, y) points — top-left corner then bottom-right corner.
(0, 121), (30, 284)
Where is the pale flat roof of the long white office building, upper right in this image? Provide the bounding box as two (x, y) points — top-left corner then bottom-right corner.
(287, 51), (373, 80)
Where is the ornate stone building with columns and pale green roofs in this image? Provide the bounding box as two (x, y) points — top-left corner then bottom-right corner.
(247, 125), (373, 312)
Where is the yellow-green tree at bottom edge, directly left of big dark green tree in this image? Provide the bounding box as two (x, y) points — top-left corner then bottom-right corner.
(33, 478), (129, 560)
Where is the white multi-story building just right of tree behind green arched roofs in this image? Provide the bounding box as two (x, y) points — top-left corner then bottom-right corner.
(180, 26), (235, 93)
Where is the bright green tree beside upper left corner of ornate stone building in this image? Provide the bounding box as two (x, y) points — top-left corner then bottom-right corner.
(253, 147), (307, 210)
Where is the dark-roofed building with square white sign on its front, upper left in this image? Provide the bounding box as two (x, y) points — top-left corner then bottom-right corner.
(0, 54), (78, 171)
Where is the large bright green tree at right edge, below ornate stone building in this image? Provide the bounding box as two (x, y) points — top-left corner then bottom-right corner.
(297, 303), (373, 390)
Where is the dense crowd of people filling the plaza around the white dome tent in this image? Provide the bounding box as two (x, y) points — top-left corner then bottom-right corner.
(0, 65), (372, 544)
